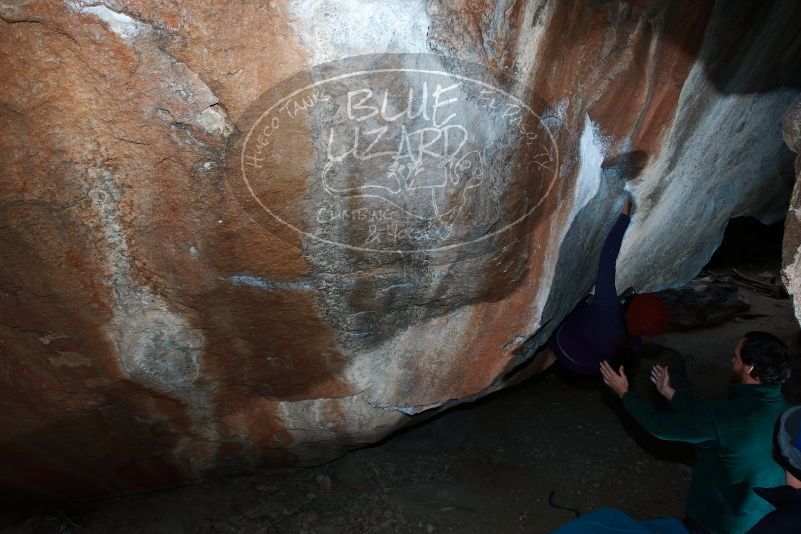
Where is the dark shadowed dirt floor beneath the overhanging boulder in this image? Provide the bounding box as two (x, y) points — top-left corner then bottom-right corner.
(0, 266), (801, 534)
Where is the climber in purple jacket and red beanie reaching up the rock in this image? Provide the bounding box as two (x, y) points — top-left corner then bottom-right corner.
(540, 198), (668, 374)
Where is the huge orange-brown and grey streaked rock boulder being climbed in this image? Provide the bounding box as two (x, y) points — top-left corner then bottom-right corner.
(0, 0), (801, 498)
